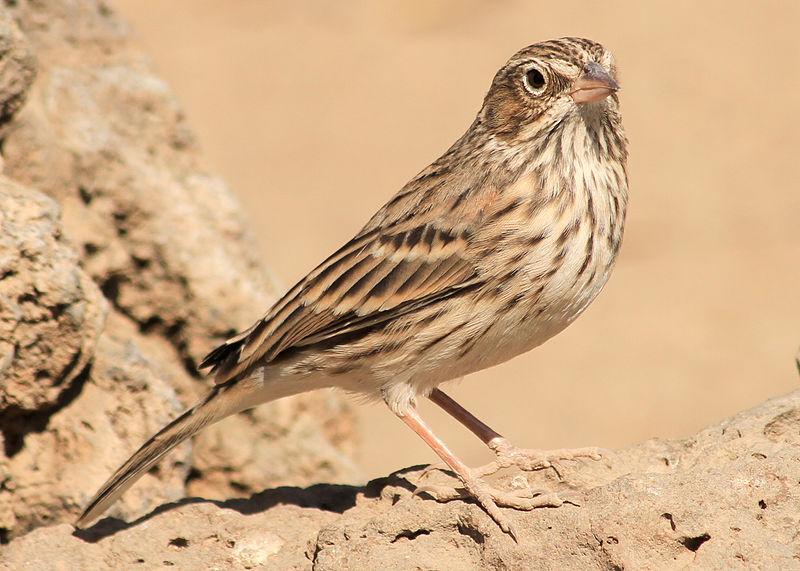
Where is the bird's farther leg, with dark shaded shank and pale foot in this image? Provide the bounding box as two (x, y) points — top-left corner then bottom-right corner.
(428, 389), (602, 478)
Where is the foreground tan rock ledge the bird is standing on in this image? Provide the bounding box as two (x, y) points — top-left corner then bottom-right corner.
(0, 391), (800, 571)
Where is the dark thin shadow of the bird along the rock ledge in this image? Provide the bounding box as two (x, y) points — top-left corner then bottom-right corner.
(72, 466), (425, 543)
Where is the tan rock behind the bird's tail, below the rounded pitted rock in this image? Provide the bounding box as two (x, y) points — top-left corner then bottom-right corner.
(0, 313), (190, 537)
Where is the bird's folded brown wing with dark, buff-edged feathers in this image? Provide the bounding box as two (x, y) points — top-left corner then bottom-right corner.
(200, 222), (478, 383)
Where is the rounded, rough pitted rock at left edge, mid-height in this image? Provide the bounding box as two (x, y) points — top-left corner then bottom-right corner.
(0, 176), (107, 420)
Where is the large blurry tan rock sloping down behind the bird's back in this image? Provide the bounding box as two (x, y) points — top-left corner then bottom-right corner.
(3, 0), (275, 370)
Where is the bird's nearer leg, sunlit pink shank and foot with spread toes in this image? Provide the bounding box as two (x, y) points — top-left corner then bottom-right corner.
(396, 406), (563, 541)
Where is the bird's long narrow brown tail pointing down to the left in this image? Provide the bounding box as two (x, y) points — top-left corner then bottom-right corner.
(75, 382), (268, 528)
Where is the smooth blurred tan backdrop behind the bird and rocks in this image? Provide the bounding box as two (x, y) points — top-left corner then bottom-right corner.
(112, 0), (800, 476)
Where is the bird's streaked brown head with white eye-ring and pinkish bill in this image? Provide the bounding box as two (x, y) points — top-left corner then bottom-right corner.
(479, 38), (619, 141)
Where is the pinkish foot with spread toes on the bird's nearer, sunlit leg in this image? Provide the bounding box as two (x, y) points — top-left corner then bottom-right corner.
(414, 469), (577, 541)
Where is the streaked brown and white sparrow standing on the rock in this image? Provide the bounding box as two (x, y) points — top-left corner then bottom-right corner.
(78, 38), (627, 535)
